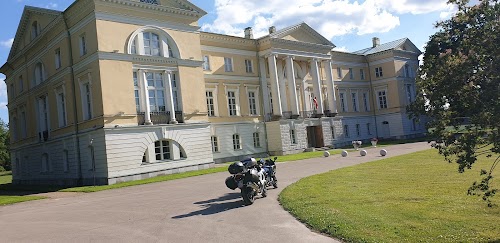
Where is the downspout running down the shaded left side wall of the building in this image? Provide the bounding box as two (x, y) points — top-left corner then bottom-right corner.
(63, 15), (83, 186)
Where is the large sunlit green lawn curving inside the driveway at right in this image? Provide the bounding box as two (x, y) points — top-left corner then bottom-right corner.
(279, 150), (500, 242)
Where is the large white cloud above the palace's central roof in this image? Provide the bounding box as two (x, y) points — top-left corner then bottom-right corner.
(202, 0), (449, 39)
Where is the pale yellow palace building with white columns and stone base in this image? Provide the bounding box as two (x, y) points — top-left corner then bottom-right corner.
(0, 0), (425, 185)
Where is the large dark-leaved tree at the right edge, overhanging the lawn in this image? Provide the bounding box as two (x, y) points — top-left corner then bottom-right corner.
(408, 0), (500, 206)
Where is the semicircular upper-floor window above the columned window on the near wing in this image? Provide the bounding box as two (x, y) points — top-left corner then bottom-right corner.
(128, 26), (180, 58)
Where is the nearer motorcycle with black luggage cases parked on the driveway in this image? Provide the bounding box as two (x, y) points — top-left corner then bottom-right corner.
(226, 158), (267, 205)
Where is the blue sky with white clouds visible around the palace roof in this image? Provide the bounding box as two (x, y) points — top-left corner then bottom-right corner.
(0, 0), (455, 122)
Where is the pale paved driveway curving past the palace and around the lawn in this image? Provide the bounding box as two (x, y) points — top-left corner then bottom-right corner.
(0, 143), (429, 243)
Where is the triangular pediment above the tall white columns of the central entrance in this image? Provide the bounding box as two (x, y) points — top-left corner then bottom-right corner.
(270, 23), (335, 48)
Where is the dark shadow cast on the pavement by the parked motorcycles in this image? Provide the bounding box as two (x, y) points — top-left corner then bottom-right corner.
(172, 193), (243, 219)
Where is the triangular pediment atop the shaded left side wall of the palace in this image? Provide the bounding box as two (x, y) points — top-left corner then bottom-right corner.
(9, 6), (62, 60)
